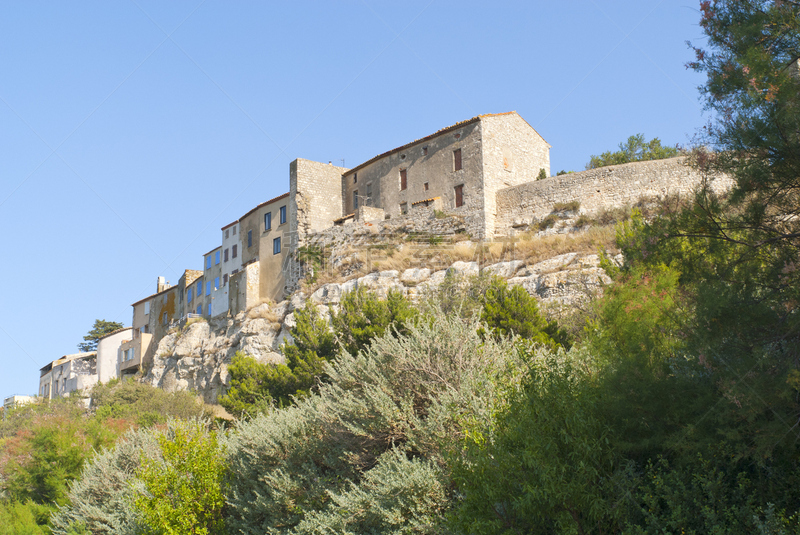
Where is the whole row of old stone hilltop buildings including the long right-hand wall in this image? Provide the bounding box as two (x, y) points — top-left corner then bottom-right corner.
(28, 112), (726, 406)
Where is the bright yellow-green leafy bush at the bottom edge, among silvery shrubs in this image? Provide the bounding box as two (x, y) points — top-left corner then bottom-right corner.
(134, 422), (225, 535)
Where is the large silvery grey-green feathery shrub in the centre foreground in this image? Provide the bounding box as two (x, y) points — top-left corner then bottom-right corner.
(225, 317), (523, 535)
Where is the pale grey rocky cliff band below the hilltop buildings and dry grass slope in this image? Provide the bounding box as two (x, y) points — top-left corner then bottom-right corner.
(142, 253), (622, 403)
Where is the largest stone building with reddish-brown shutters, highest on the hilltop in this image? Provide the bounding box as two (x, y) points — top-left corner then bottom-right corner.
(342, 112), (550, 237)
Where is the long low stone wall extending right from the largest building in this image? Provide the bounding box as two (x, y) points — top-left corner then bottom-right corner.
(495, 157), (733, 235)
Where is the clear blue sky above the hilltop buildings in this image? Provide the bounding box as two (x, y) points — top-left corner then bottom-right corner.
(0, 0), (705, 397)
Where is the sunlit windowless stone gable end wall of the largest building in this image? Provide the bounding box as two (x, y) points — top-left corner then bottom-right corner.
(481, 112), (550, 238)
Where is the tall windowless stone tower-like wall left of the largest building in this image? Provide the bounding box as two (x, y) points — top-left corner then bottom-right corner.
(290, 158), (347, 245)
